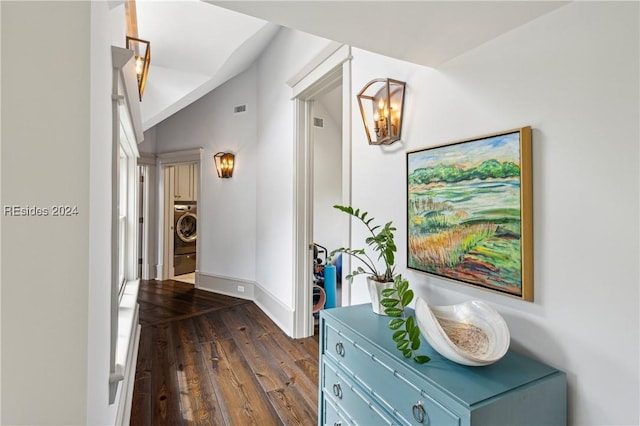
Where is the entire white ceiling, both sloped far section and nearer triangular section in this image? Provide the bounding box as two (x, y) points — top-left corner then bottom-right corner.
(137, 0), (568, 129)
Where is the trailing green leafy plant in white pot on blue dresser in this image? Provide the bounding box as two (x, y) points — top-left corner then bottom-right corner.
(329, 205), (430, 364)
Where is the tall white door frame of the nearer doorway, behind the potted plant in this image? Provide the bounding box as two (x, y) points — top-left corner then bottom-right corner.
(287, 42), (352, 338)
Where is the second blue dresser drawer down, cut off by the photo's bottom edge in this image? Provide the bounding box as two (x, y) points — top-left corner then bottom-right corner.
(320, 360), (397, 426)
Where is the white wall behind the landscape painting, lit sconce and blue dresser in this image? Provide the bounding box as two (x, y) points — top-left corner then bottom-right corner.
(352, 2), (640, 425)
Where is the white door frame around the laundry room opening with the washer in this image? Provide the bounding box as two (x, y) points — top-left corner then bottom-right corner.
(156, 148), (204, 287)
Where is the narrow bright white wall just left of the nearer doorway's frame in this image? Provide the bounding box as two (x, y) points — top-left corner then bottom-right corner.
(256, 29), (336, 312)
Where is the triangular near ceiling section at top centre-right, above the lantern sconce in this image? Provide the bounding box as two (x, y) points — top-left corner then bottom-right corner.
(206, 0), (568, 67)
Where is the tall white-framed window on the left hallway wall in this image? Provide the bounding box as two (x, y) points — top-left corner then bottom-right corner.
(109, 47), (143, 408)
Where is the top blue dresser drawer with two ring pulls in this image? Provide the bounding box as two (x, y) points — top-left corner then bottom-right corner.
(324, 316), (460, 426)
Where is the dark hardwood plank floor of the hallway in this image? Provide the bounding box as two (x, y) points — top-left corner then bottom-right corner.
(131, 280), (318, 426)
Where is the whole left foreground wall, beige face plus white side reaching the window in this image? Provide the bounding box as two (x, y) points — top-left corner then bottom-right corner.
(0, 2), (132, 425)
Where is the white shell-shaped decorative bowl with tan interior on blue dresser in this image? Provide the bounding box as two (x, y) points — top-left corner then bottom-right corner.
(415, 298), (510, 366)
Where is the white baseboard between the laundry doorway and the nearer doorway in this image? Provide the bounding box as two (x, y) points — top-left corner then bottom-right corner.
(196, 272), (294, 336)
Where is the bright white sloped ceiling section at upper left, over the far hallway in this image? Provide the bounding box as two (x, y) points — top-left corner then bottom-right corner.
(136, 0), (280, 130)
